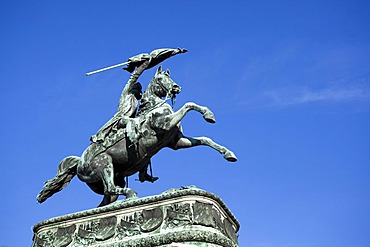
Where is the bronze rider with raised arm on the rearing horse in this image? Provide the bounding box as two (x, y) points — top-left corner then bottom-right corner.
(90, 55), (158, 182)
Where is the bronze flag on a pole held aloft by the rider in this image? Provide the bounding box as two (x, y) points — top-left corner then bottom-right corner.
(85, 48), (188, 76)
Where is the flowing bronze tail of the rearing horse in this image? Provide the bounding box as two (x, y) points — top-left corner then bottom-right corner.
(37, 156), (80, 203)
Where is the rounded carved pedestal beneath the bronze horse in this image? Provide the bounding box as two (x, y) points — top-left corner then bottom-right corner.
(33, 187), (239, 247)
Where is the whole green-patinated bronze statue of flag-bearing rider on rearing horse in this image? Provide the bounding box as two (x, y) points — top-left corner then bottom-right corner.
(37, 48), (237, 207)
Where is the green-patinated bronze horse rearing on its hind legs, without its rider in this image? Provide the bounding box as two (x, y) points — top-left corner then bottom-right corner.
(37, 66), (237, 206)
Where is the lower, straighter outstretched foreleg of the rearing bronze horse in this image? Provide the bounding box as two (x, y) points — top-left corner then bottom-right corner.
(173, 136), (237, 162)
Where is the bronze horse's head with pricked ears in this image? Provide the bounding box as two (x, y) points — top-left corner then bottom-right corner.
(151, 66), (181, 98)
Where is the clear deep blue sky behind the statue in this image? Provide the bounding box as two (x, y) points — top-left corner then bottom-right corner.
(0, 0), (370, 247)
